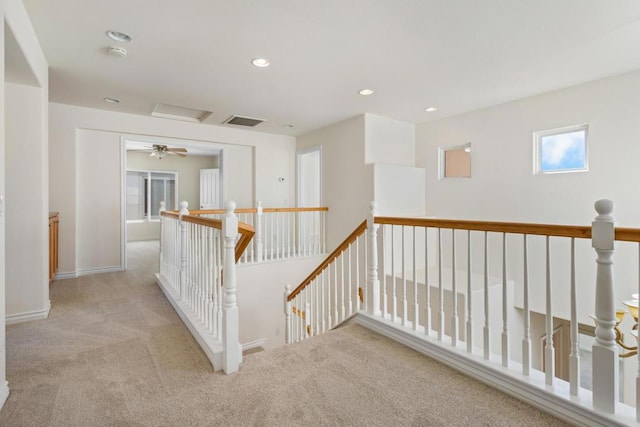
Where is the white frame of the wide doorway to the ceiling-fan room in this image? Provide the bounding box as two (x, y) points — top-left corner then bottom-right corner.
(120, 134), (227, 270)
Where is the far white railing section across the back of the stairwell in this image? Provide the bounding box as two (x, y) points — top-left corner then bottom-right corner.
(191, 202), (329, 264)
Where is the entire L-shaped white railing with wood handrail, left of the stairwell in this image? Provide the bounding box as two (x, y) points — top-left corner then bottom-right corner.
(156, 202), (328, 374)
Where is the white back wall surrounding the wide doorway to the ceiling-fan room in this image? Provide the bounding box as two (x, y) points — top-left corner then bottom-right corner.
(49, 103), (295, 277)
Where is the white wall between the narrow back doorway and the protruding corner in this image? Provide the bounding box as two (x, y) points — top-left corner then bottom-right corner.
(297, 116), (373, 251)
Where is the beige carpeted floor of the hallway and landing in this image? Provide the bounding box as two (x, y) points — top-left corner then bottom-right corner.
(0, 245), (565, 426)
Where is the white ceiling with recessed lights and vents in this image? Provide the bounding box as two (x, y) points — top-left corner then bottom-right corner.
(24, 0), (640, 135)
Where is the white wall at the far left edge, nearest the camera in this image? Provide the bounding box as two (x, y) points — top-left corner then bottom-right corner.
(0, 0), (49, 407)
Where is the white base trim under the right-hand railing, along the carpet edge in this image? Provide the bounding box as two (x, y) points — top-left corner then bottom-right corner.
(353, 312), (637, 426)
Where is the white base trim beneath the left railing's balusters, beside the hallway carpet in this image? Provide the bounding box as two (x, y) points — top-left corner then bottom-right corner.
(155, 273), (222, 371)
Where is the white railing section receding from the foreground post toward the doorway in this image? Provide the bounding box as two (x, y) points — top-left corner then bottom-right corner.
(158, 201), (254, 374)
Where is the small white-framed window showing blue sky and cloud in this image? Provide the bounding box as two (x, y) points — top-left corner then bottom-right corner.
(533, 125), (589, 174)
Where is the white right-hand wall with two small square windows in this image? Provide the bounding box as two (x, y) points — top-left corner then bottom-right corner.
(416, 68), (640, 323)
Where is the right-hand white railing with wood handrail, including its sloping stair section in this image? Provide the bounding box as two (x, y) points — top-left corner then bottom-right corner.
(284, 200), (640, 425)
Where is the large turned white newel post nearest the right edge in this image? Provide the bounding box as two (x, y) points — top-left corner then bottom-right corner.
(591, 199), (618, 413)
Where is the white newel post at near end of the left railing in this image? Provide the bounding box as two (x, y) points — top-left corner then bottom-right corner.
(222, 201), (242, 374)
